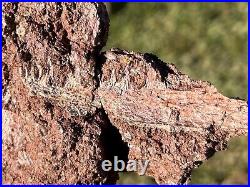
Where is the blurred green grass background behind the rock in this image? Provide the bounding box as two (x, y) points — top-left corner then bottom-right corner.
(104, 3), (248, 184)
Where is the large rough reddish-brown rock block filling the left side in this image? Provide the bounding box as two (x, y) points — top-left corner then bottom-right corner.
(2, 3), (117, 184)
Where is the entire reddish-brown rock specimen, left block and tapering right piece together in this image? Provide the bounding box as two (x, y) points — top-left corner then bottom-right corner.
(2, 3), (248, 184)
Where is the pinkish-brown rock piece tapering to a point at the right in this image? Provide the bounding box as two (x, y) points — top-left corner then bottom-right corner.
(98, 49), (248, 184)
